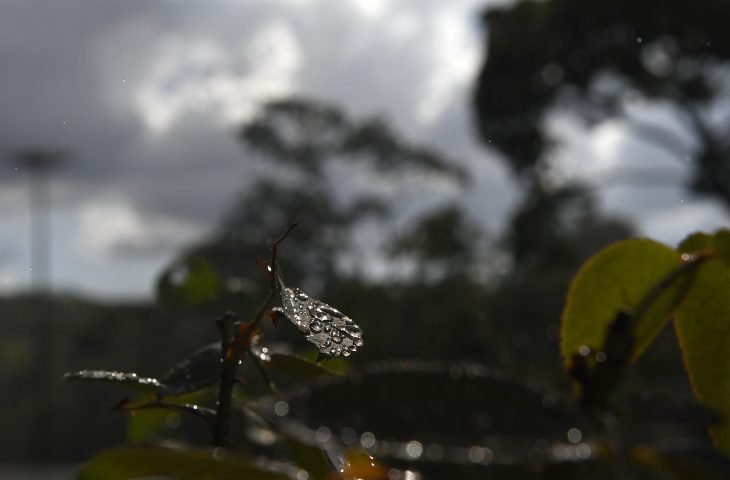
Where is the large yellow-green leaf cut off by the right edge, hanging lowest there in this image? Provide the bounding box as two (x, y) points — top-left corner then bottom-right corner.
(674, 259), (730, 454)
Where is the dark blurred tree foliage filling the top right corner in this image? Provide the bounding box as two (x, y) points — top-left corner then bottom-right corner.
(474, 0), (730, 205)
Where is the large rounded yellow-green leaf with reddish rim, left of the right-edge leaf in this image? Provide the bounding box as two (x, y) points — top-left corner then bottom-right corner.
(561, 239), (686, 368)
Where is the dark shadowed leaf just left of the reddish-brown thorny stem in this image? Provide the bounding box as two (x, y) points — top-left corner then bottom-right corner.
(162, 343), (221, 395)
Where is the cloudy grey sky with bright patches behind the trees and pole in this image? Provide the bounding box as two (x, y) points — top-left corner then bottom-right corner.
(0, 0), (728, 298)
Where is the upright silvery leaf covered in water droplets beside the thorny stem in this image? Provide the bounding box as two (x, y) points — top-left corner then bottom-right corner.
(281, 288), (364, 357)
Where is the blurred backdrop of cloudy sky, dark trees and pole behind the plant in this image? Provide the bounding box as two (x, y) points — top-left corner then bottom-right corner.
(0, 0), (730, 472)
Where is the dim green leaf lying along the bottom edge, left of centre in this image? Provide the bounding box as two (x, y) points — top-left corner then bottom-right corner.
(77, 447), (289, 480)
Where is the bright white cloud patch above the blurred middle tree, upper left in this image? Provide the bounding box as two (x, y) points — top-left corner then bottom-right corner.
(134, 21), (302, 133)
